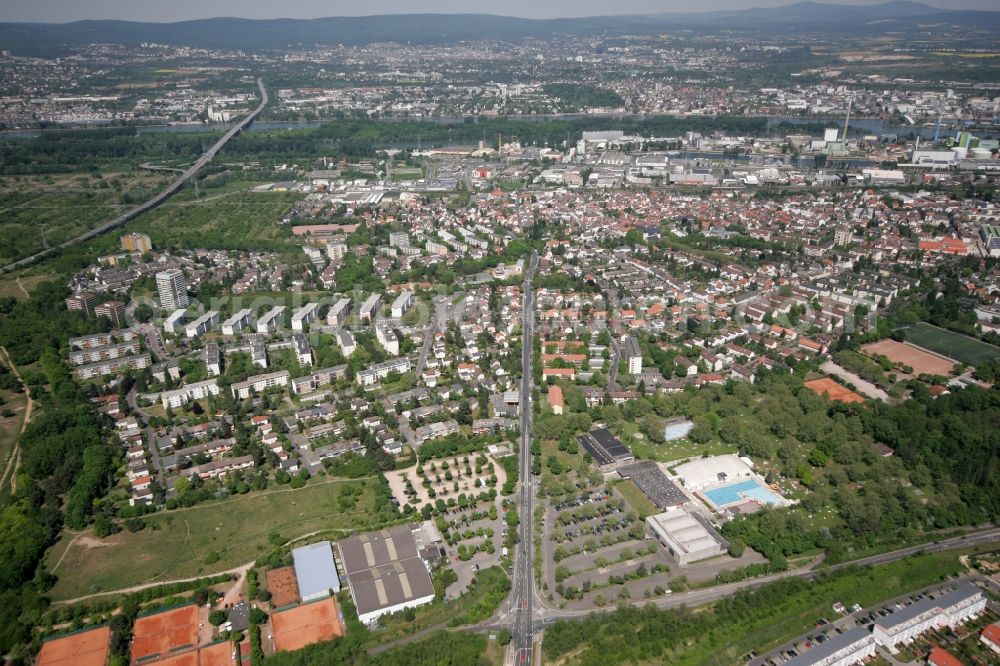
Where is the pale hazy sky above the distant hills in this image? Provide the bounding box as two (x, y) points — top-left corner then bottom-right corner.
(0, 0), (984, 23)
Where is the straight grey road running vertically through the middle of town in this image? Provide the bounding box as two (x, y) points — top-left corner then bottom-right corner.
(507, 254), (538, 664)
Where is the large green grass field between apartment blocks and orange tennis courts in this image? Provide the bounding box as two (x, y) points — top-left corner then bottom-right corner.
(46, 477), (388, 600)
